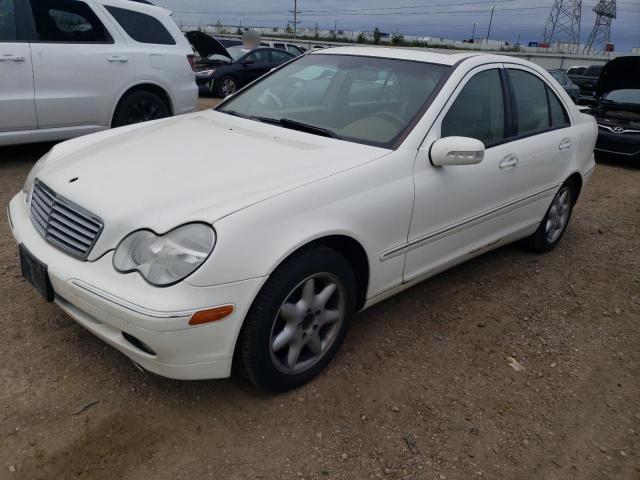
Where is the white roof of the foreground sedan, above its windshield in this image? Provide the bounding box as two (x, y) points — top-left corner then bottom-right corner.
(309, 46), (482, 66)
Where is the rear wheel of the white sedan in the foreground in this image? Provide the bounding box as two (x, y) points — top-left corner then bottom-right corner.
(529, 182), (575, 253)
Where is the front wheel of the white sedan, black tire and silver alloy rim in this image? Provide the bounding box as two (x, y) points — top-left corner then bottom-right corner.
(234, 246), (356, 392)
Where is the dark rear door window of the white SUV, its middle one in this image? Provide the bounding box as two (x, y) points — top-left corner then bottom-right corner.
(31, 0), (113, 43)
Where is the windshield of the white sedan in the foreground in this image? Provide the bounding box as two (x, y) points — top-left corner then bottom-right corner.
(218, 54), (450, 148)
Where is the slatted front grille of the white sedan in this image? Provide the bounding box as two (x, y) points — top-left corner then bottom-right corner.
(29, 180), (103, 259)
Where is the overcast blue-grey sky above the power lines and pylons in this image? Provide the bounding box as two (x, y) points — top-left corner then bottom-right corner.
(160, 0), (640, 52)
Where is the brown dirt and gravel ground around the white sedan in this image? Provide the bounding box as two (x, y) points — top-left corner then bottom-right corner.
(0, 103), (640, 480)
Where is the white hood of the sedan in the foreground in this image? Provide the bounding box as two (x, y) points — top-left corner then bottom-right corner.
(38, 110), (389, 260)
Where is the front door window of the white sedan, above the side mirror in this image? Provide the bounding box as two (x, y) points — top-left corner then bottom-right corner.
(441, 68), (504, 147)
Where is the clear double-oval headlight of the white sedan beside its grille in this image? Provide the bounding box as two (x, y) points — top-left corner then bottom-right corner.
(113, 223), (216, 287)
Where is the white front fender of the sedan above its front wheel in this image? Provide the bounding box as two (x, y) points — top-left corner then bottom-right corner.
(187, 151), (413, 296)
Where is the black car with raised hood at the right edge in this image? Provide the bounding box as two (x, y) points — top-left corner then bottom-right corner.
(591, 56), (640, 161)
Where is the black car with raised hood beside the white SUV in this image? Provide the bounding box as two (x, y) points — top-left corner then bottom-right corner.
(186, 31), (295, 97)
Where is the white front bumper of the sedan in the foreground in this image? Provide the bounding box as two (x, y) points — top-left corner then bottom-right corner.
(9, 193), (266, 380)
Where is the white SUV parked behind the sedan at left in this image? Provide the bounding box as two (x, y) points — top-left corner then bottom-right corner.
(0, 0), (198, 145)
